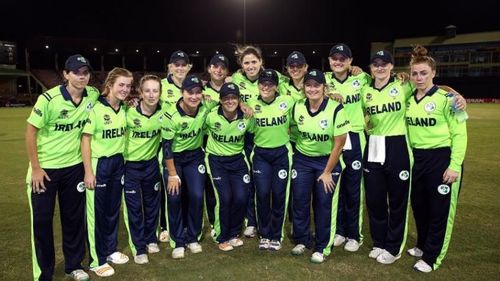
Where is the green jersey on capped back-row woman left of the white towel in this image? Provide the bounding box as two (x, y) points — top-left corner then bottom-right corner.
(325, 72), (371, 133)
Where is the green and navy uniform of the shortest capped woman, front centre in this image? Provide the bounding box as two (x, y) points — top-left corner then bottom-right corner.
(205, 107), (253, 243)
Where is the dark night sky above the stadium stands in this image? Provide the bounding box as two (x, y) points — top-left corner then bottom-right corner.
(0, 0), (500, 66)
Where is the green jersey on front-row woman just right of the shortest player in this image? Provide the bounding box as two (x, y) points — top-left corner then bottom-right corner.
(248, 95), (295, 148)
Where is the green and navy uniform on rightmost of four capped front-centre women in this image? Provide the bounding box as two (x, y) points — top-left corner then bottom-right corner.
(292, 98), (351, 256)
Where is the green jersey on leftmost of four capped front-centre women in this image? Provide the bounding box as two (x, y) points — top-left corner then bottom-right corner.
(162, 101), (216, 153)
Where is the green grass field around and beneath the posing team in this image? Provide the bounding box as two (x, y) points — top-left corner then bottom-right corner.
(0, 104), (500, 280)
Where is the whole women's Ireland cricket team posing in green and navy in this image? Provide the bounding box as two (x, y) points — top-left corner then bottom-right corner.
(26, 44), (467, 280)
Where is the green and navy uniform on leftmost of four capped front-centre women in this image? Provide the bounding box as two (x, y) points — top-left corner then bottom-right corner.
(162, 101), (214, 248)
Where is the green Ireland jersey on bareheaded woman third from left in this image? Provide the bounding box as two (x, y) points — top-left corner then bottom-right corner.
(124, 102), (163, 161)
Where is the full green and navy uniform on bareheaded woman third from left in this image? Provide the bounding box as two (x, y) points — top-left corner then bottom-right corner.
(124, 105), (163, 256)
